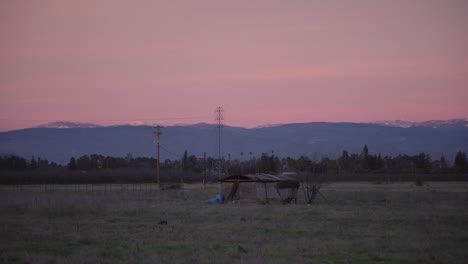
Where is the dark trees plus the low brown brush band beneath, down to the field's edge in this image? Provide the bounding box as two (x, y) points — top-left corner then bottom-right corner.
(0, 145), (468, 184)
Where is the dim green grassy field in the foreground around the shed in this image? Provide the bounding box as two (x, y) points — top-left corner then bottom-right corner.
(0, 182), (468, 263)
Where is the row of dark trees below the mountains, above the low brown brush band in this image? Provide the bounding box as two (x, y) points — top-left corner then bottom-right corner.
(0, 145), (468, 174)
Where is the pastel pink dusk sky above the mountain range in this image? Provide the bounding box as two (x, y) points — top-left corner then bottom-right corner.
(0, 0), (468, 131)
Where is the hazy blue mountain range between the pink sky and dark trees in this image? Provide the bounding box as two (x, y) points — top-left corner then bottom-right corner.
(0, 119), (468, 164)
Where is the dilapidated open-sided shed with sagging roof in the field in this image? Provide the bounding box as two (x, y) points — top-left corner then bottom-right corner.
(221, 173), (300, 203)
